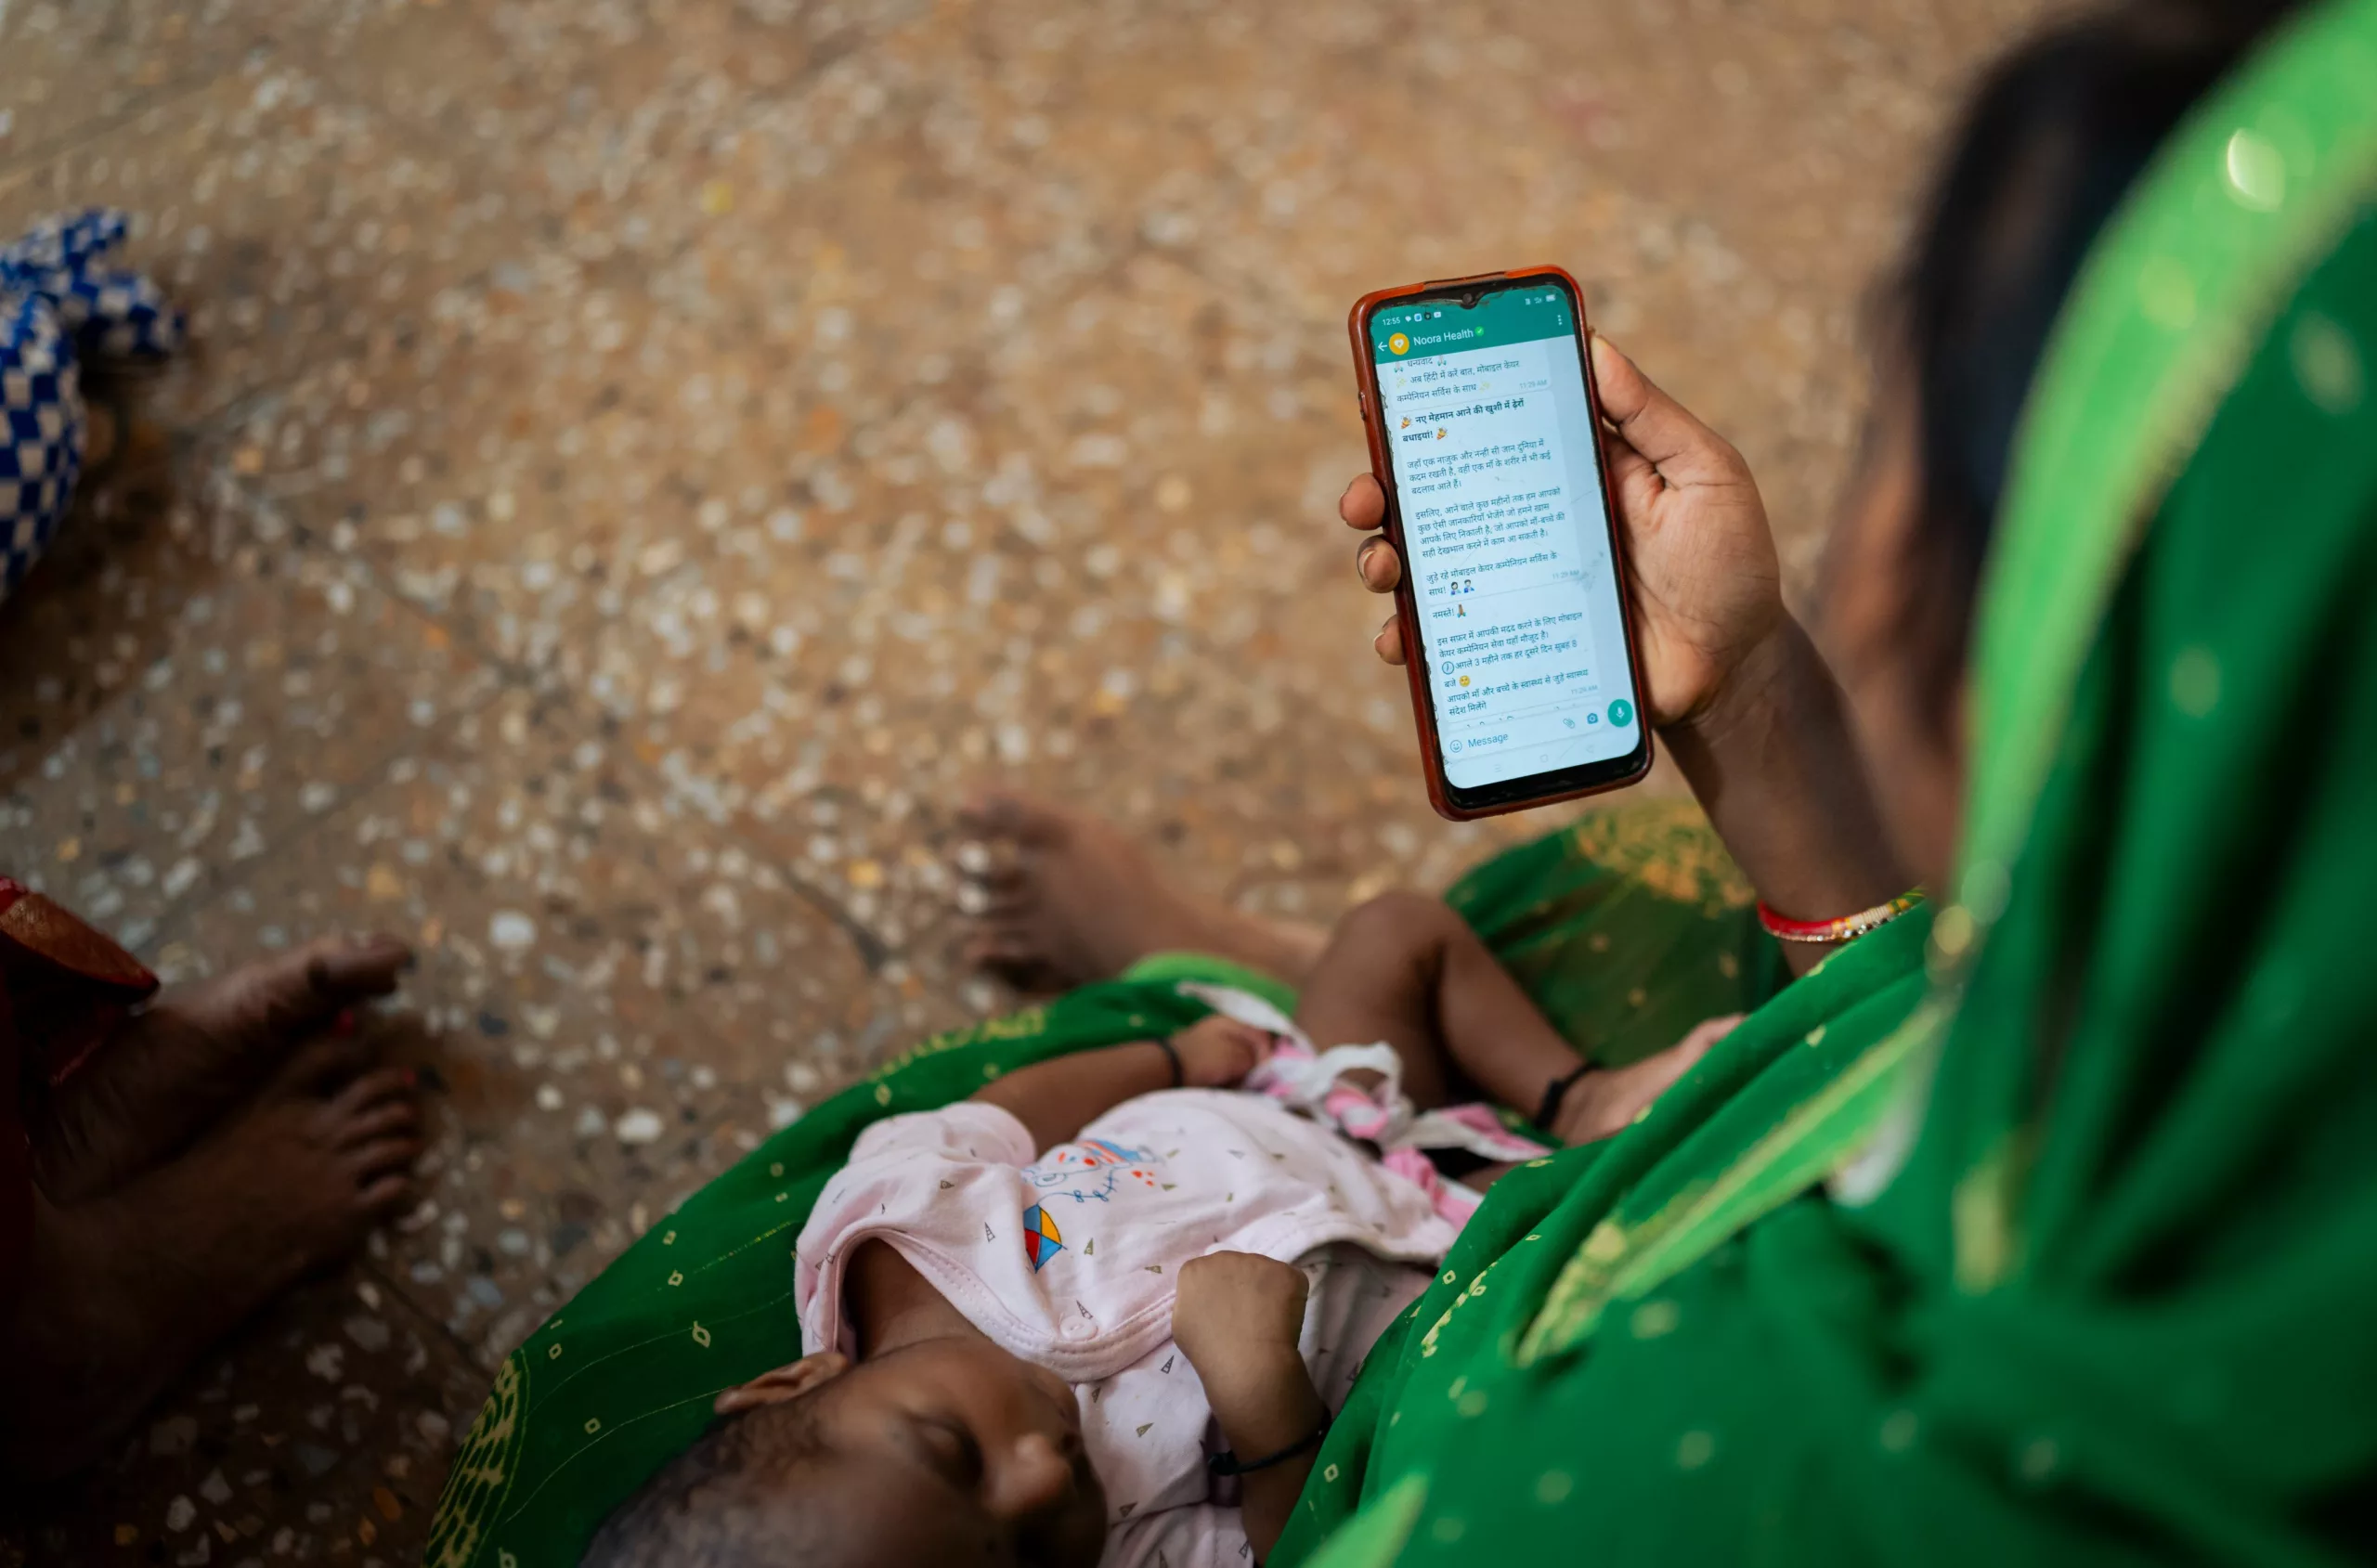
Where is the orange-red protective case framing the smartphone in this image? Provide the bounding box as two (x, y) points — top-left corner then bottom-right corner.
(1345, 266), (1655, 822)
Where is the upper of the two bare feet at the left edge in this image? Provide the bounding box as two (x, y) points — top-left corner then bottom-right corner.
(29, 936), (411, 1207)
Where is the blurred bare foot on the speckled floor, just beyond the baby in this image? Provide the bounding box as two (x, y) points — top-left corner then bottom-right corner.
(958, 791), (1329, 993)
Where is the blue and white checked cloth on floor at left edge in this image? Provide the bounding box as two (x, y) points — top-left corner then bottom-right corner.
(0, 209), (181, 599)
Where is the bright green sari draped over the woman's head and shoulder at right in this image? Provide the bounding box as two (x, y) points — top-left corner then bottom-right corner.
(1274, 0), (2377, 1568)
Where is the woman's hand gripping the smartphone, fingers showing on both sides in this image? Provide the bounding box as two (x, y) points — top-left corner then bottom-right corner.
(1338, 335), (1786, 727)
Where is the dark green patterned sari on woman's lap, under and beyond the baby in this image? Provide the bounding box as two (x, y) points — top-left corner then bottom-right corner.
(425, 800), (1783, 1568)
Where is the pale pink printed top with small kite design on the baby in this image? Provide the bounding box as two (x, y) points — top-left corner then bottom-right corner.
(794, 1088), (1455, 1568)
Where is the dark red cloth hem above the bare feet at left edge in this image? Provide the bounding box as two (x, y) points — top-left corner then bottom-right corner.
(0, 876), (157, 1312)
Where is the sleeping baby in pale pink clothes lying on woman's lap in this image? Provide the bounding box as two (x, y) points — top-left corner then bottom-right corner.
(587, 902), (1714, 1568)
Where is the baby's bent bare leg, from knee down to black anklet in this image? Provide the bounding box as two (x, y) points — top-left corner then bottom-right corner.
(1295, 893), (1583, 1114)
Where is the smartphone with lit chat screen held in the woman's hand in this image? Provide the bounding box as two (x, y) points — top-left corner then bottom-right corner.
(1348, 266), (1652, 822)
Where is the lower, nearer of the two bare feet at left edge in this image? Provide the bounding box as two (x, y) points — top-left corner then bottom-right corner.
(0, 1038), (421, 1480)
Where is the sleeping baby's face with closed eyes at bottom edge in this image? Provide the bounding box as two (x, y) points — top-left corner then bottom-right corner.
(799, 1340), (1105, 1568)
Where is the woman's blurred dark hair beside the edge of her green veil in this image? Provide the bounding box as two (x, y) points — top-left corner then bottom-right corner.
(1885, 0), (2299, 698)
